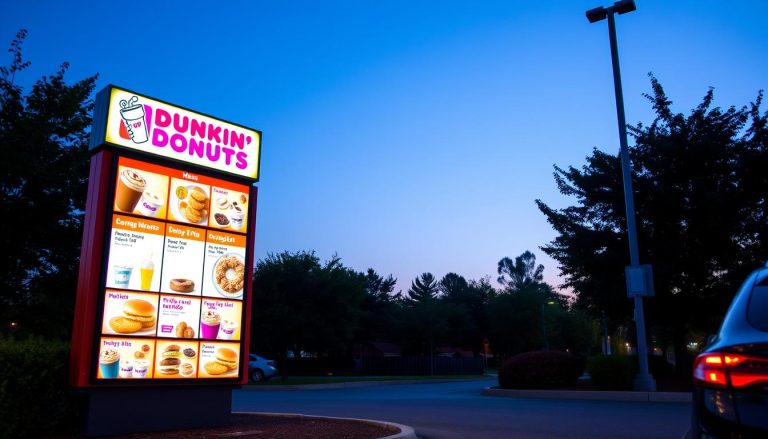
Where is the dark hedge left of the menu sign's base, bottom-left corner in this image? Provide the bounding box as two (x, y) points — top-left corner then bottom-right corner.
(0, 339), (77, 437)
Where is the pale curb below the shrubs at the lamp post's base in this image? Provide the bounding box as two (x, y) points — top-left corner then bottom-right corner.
(481, 387), (692, 402)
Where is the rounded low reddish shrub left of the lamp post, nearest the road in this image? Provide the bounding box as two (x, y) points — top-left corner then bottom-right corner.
(499, 351), (584, 389)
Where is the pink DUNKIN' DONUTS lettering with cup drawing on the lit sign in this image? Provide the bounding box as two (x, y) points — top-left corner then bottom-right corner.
(114, 95), (258, 170)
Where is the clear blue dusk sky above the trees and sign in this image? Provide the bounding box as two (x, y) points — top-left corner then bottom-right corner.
(0, 0), (768, 290)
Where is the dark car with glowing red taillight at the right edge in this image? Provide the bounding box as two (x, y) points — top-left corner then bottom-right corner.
(689, 264), (768, 439)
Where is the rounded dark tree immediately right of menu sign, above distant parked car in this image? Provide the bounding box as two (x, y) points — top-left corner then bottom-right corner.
(251, 251), (366, 373)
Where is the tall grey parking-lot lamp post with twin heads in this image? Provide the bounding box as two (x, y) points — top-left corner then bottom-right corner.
(587, 0), (656, 391)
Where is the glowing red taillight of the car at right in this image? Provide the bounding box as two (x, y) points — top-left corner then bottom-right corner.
(693, 352), (768, 387)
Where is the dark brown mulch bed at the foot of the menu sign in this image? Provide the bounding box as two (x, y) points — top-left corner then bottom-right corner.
(56, 414), (400, 439)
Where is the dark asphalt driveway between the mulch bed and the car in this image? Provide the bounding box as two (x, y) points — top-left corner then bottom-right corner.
(232, 378), (691, 439)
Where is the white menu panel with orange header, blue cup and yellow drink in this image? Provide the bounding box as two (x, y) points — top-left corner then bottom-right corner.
(107, 214), (165, 291)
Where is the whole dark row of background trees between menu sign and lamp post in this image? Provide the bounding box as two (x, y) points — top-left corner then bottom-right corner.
(251, 252), (595, 372)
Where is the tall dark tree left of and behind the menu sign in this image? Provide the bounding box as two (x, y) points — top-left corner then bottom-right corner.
(0, 30), (96, 338)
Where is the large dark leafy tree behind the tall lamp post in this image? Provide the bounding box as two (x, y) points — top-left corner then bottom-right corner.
(536, 76), (768, 372)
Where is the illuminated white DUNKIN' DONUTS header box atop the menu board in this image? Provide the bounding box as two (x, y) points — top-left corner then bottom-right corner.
(91, 86), (261, 180)
